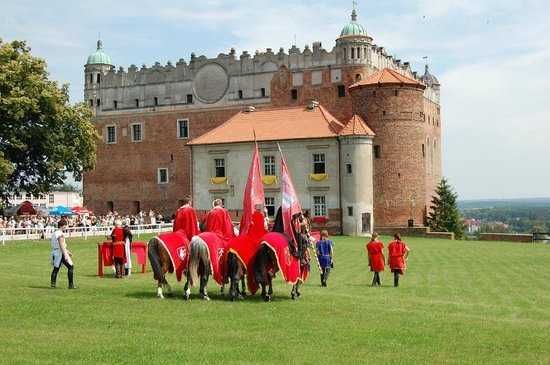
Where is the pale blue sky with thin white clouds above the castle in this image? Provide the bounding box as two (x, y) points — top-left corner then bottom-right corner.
(0, 0), (550, 199)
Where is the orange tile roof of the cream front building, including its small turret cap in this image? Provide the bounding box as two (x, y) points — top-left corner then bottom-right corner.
(188, 105), (372, 145)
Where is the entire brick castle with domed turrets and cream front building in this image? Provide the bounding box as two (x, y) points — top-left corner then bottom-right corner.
(84, 10), (442, 234)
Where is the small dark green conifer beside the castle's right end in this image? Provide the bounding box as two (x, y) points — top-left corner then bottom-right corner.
(428, 179), (464, 239)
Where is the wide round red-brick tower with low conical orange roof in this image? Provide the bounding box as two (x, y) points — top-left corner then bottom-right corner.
(350, 69), (427, 227)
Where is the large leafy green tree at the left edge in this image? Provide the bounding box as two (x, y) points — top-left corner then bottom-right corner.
(0, 39), (98, 200)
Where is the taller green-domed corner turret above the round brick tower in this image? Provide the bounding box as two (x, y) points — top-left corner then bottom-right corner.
(336, 9), (372, 65)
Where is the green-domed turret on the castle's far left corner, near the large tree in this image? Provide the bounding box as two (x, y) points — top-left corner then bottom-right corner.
(84, 40), (114, 110)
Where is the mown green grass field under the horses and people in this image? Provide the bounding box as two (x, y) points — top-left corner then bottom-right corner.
(0, 237), (550, 364)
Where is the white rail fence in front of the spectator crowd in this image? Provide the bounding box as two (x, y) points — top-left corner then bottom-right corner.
(0, 223), (172, 245)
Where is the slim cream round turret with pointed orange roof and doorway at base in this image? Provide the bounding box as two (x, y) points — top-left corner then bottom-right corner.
(338, 115), (374, 236)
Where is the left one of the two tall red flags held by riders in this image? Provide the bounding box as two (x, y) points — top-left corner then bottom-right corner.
(239, 143), (264, 236)
